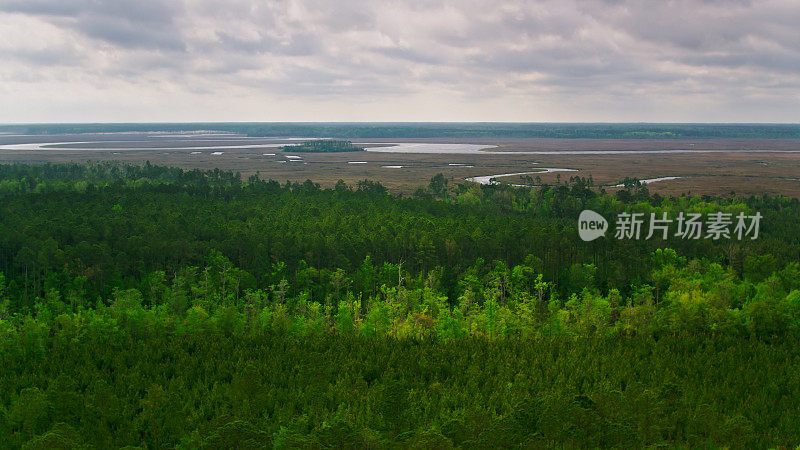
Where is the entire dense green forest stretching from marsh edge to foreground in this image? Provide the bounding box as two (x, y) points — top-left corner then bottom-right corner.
(0, 163), (800, 448)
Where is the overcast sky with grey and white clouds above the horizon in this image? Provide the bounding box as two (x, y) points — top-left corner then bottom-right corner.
(0, 0), (800, 123)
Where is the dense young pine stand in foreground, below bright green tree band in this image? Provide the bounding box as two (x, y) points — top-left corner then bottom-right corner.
(0, 331), (800, 448)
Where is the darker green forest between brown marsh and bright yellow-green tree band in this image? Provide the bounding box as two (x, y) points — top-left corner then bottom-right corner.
(0, 164), (800, 315)
